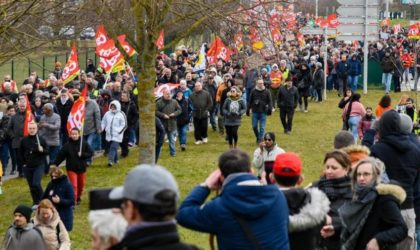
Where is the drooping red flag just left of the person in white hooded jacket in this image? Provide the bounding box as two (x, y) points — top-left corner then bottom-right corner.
(67, 85), (87, 137)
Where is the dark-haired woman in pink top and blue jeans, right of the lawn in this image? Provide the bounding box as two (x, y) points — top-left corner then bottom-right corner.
(342, 93), (366, 143)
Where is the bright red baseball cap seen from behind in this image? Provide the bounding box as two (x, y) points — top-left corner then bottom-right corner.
(273, 152), (302, 177)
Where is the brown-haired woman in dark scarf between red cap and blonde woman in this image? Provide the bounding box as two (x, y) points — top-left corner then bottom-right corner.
(312, 150), (351, 250)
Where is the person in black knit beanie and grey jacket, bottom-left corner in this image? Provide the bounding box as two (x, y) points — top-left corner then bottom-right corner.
(1, 205), (49, 250)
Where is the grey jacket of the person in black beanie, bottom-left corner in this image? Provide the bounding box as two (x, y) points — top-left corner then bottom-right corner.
(1, 223), (48, 250)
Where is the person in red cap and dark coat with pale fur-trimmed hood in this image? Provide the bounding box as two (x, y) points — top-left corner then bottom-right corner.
(270, 152), (330, 250)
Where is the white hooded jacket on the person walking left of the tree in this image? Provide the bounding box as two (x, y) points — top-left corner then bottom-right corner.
(101, 100), (127, 143)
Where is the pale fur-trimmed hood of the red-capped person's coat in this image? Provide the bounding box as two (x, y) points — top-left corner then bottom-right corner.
(283, 188), (330, 232)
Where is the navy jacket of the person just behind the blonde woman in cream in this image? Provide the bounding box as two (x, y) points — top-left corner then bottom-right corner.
(42, 175), (74, 232)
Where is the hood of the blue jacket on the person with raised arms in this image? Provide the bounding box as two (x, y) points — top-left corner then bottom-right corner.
(221, 173), (282, 219)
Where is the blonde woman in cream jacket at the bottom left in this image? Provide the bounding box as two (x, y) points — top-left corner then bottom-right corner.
(33, 199), (71, 250)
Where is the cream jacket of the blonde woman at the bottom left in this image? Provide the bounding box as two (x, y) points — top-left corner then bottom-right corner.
(33, 208), (71, 250)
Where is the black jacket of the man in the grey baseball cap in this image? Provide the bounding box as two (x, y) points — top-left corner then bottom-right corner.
(111, 224), (198, 250)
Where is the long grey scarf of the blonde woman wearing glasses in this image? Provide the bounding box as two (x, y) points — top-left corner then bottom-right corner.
(338, 184), (378, 250)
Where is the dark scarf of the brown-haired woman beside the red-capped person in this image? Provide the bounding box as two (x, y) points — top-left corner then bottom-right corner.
(314, 176), (351, 201)
